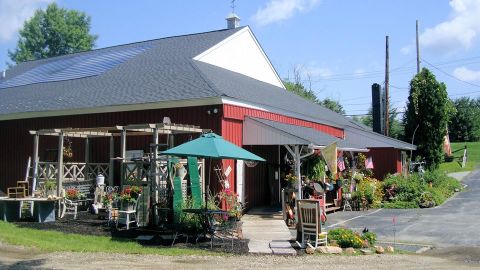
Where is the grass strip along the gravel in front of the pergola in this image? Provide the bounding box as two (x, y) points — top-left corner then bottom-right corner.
(0, 221), (219, 256)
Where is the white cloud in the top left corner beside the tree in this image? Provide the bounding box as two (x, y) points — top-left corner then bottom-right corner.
(0, 0), (53, 42)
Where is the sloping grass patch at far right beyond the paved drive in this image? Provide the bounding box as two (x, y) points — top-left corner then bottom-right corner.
(440, 142), (480, 173)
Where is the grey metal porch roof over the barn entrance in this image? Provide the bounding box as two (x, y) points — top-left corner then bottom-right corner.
(243, 117), (368, 152)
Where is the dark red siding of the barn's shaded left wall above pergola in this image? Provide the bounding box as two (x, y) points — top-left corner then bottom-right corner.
(0, 106), (222, 192)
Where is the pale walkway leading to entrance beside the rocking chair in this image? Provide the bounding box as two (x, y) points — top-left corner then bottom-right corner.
(242, 208), (297, 255)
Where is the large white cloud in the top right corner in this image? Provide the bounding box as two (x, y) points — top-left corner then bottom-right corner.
(420, 0), (480, 53)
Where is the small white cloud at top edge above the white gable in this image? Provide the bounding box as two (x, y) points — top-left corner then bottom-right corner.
(252, 0), (320, 25)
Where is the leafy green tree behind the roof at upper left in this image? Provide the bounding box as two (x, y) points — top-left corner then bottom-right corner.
(8, 3), (97, 64)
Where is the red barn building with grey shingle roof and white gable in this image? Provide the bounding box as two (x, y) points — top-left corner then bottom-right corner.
(0, 24), (412, 207)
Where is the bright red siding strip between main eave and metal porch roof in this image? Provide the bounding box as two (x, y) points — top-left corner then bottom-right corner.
(223, 104), (344, 139)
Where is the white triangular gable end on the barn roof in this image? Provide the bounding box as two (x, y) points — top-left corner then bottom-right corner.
(194, 27), (285, 88)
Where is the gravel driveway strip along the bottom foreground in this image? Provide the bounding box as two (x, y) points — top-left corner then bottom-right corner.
(0, 243), (478, 270)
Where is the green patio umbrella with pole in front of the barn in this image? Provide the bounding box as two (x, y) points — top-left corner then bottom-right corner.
(161, 133), (265, 211)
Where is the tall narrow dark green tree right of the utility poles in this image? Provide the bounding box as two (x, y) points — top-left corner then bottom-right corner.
(404, 68), (452, 169)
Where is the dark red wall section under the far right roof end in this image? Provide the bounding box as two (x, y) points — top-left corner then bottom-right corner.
(367, 148), (402, 179)
